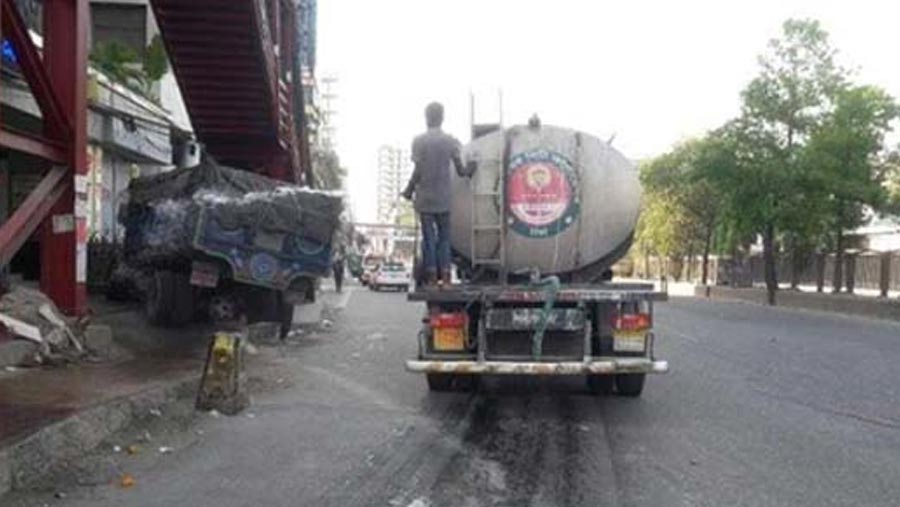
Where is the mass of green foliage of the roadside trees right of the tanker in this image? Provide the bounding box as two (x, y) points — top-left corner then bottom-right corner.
(638, 20), (900, 297)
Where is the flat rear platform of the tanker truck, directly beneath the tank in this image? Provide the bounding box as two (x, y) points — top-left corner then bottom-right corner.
(407, 283), (669, 303)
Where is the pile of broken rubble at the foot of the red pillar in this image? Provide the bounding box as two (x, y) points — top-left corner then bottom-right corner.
(0, 287), (86, 364)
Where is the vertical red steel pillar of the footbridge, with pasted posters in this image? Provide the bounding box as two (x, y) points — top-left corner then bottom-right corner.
(41, 0), (89, 315)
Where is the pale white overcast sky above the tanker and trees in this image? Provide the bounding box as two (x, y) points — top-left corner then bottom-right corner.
(317, 0), (900, 220)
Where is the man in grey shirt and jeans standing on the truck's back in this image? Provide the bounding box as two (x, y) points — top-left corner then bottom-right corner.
(402, 102), (474, 285)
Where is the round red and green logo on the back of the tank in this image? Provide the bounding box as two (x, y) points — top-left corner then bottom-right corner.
(506, 150), (579, 238)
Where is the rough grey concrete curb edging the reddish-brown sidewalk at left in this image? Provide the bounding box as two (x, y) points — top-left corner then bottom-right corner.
(0, 373), (200, 498)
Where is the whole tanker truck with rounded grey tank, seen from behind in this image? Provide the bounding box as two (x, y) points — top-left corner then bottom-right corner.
(406, 118), (668, 397)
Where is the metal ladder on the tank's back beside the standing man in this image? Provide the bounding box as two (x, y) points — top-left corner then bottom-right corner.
(469, 92), (509, 285)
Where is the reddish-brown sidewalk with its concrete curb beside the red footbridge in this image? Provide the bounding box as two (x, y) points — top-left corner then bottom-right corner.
(0, 301), (210, 497)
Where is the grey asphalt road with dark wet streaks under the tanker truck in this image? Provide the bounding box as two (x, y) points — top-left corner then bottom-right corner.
(17, 287), (900, 507)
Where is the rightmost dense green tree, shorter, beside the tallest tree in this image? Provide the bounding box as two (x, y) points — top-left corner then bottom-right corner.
(804, 86), (900, 292)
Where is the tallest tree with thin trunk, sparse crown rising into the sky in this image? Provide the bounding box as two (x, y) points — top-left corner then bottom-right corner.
(732, 19), (845, 304)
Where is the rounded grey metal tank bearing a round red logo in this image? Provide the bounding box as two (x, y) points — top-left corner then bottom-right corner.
(451, 122), (641, 281)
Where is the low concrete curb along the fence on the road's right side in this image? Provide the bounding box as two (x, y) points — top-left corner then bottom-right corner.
(695, 286), (900, 322)
